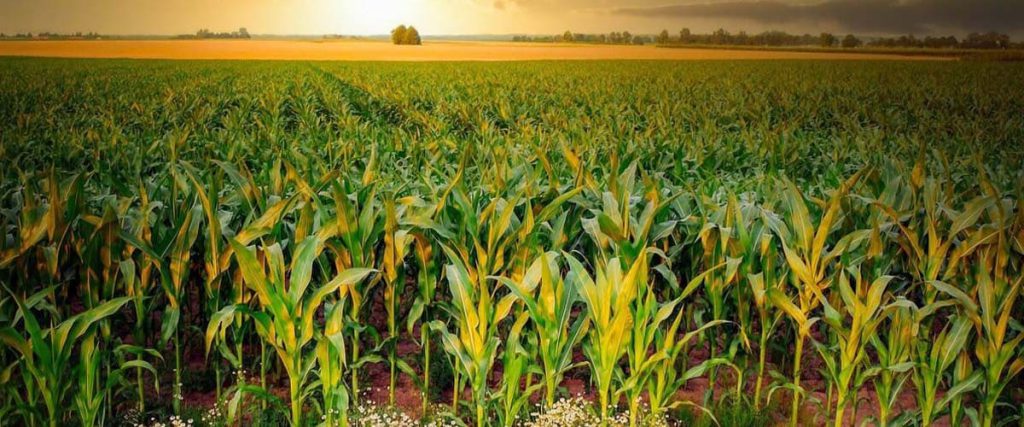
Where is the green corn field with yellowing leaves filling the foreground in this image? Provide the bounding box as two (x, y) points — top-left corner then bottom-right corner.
(0, 57), (1024, 427)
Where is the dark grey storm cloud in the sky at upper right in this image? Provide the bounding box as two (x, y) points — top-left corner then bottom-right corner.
(613, 0), (1024, 33)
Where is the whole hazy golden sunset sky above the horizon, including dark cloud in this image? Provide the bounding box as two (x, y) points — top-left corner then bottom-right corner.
(0, 0), (1024, 39)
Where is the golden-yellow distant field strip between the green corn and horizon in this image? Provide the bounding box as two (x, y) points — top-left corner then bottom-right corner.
(0, 40), (952, 61)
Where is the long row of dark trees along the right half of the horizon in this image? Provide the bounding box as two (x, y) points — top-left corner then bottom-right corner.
(512, 28), (1024, 49)
